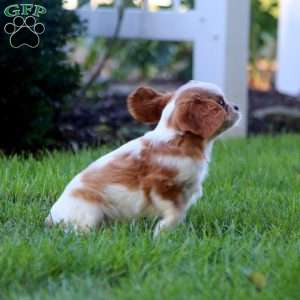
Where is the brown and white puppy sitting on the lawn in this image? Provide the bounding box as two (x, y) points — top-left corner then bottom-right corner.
(46, 81), (240, 236)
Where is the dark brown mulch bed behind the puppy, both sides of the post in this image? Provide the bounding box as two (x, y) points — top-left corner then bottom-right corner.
(59, 88), (300, 149)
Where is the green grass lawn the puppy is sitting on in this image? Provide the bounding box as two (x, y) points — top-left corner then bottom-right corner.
(0, 135), (300, 300)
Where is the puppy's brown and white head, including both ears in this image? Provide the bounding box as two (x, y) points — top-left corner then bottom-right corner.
(127, 81), (240, 140)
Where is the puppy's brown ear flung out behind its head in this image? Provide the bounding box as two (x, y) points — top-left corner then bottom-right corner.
(127, 86), (172, 123)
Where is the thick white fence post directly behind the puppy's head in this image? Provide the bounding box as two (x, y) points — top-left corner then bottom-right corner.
(193, 0), (250, 136)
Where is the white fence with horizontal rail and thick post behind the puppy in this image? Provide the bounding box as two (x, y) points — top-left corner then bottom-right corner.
(74, 0), (250, 135)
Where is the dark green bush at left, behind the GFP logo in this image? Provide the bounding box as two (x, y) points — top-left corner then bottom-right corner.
(0, 0), (84, 153)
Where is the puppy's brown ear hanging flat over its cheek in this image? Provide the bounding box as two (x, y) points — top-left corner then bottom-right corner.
(175, 99), (226, 139)
